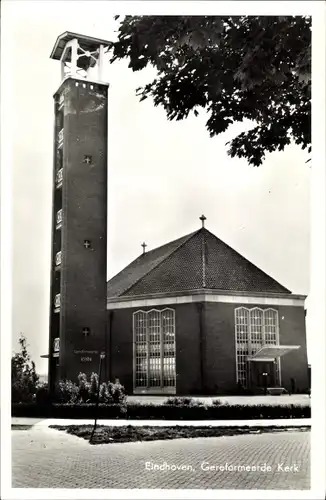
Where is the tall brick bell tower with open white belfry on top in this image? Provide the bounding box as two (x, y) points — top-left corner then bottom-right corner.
(49, 32), (110, 391)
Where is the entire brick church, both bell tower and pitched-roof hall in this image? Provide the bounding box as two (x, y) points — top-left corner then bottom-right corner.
(44, 32), (308, 395)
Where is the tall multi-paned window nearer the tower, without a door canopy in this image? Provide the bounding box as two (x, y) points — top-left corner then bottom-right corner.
(133, 309), (176, 390)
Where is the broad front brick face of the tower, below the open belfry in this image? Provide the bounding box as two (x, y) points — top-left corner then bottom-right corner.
(52, 79), (107, 380)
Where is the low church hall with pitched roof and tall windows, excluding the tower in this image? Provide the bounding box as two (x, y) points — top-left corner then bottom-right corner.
(107, 216), (308, 395)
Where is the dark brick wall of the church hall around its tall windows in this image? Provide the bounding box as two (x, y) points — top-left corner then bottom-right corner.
(110, 303), (308, 395)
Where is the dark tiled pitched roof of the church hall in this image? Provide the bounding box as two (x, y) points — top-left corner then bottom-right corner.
(108, 228), (291, 299)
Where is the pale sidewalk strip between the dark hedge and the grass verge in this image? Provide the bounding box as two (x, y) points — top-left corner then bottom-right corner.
(11, 417), (311, 428)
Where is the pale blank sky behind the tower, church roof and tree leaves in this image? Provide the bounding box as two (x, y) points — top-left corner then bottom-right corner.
(3, 0), (312, 373)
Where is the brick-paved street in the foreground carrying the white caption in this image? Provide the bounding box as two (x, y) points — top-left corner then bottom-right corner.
(12, 427), (310, 490)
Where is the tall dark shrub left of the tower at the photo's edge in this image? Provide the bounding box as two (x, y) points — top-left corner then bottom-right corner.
(11, 333), (39, 403)
